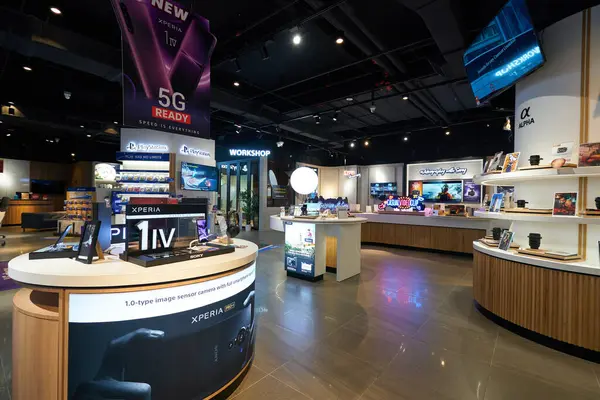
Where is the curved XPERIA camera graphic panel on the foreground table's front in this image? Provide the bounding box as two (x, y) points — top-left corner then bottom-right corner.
(68, 265), (256, 400)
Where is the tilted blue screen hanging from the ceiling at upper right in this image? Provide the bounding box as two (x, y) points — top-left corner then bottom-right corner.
(463, 0), (545, 105)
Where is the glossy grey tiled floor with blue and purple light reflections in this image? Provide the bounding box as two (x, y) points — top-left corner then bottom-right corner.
(0, 229), (600, 400)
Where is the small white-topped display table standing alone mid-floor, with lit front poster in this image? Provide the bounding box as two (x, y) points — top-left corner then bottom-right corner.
(271, 215), (366, 282)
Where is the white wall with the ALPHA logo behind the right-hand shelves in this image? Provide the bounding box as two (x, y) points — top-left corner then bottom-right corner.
(513, 6), (600, 265)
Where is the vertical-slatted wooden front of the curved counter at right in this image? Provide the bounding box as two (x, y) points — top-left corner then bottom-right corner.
(473, 251), (600, 351)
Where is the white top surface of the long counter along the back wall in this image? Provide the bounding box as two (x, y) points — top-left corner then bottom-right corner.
(354, 211), (490, 229)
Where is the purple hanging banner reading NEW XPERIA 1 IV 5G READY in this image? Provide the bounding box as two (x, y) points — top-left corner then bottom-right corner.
(111, 0), (217, 137)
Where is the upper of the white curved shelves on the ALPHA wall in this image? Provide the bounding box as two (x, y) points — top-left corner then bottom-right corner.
(473, 167), (600, 185)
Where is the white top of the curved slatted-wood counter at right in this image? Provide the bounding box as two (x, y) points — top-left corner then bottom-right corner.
(473, 242), (600, 276)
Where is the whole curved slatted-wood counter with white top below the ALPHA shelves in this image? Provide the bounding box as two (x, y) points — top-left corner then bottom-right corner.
(473, 242), (600, 361)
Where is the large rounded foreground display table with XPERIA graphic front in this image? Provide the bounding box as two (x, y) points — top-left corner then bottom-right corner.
(8, 240), (258, 400)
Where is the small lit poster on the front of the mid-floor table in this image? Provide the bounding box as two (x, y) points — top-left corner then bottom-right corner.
(284, 222), (315, 276)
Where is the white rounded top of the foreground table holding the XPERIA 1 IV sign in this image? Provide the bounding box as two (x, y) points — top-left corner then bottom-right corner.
(8, 239), (258, 288)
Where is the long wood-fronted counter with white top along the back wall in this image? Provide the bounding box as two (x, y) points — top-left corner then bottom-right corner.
(356, 212), (491, 254)
